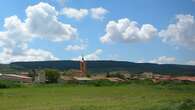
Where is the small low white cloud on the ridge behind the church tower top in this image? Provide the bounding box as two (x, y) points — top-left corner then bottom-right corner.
(72, 49), (102, 60)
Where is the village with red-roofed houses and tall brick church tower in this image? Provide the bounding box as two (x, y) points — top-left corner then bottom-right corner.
(0, 58), (195, 84)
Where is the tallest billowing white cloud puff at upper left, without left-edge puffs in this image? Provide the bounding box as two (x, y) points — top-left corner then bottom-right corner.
(25, 2), (77, 41)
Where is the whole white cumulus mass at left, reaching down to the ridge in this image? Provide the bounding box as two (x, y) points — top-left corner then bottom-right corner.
(0, 2), (80, 63)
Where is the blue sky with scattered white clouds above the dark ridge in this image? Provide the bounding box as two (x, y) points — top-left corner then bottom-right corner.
(0, 0), (195, 65)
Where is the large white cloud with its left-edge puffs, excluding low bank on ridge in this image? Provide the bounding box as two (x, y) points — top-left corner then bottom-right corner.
(0, 3), (77, 49)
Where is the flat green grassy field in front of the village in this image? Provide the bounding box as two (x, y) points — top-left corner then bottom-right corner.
(0, 84), (195, 110)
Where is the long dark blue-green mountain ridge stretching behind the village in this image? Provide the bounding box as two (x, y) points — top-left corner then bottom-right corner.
(0, 60), (195, 75)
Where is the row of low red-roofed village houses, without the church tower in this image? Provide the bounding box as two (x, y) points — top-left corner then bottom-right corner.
(0, 72), (195, 83)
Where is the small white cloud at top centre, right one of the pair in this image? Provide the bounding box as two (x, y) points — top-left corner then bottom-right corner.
(91, 7), (108, 20)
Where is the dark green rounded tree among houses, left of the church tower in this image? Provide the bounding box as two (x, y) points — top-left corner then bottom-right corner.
(45, 69), (60, 83)
